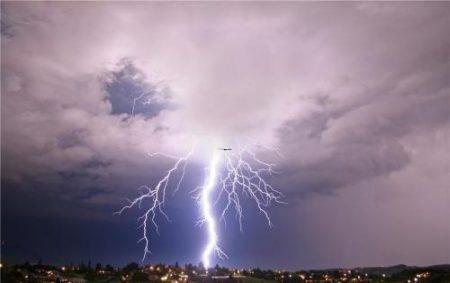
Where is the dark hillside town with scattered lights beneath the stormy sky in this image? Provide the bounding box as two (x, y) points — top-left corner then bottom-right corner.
(0, 262), (450, 283)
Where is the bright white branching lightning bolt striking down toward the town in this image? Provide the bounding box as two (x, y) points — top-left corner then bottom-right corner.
(117, 143), (283, 271)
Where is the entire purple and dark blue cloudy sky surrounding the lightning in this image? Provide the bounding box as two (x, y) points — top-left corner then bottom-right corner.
(1, 2), (450, 268)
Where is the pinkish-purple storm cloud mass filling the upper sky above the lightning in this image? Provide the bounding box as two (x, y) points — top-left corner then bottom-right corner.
(1, 2), (450, 264)
